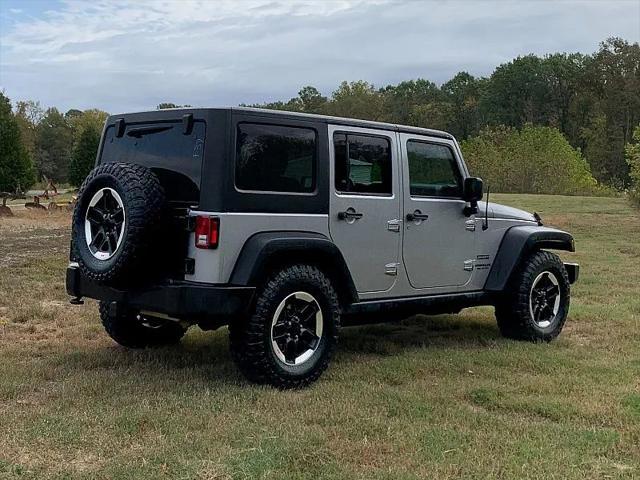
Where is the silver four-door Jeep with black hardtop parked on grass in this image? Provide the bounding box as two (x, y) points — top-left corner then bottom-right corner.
(66, 108), (578, 388)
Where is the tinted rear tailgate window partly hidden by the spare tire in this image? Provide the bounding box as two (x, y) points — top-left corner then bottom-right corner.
(100, 121), (205, 204)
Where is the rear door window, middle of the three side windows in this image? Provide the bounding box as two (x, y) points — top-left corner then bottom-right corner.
(333, 133), (392, 195)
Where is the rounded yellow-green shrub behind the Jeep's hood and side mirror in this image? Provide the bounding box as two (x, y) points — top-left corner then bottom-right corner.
(461, 125), (610, 195)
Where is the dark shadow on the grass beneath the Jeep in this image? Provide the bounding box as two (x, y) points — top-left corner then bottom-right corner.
(59, 314), (500, 386)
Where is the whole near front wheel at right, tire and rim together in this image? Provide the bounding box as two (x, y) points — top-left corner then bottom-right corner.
(496, 251), (571, 342)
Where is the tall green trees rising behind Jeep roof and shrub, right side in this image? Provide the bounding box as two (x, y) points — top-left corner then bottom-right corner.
(252, 38), (640, 189)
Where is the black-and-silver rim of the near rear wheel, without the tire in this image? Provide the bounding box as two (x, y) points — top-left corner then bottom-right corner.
(271, 292), (323, 365)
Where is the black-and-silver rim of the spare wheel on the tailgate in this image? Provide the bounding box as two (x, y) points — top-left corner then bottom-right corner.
(84, 188), (126, 260)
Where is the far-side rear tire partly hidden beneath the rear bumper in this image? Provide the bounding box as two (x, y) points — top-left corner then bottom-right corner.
(100, 302), (186, 348)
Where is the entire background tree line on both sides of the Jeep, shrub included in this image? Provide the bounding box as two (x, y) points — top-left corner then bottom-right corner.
(0, 38), (640, 197)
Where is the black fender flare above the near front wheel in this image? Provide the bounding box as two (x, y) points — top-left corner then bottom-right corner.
(484, 225), (576, 292)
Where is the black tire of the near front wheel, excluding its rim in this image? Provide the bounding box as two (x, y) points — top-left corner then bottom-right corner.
(495, 250), (571, 342)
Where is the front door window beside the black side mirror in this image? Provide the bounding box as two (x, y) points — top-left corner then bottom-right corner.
(407, 140), (462, 197)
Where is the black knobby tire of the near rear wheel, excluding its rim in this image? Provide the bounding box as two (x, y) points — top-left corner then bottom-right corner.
(229, 265), (340, 389)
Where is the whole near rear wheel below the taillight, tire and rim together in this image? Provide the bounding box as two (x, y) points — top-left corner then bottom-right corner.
(229, 265), (340, 388)
